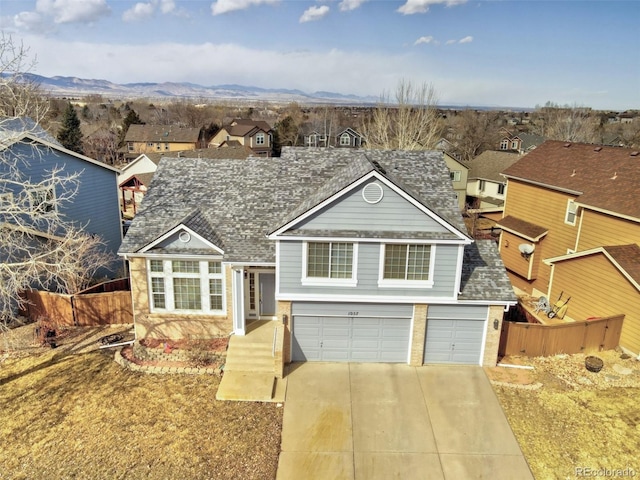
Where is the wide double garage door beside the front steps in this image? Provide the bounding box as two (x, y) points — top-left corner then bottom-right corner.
(291, 302), (413, 363)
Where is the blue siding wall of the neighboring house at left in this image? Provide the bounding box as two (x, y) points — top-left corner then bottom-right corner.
(2, 144), (122, 262)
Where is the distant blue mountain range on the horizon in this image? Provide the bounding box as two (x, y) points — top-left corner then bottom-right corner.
(10, 74), (378, 104)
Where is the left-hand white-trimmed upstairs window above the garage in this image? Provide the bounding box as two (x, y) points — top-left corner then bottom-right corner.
(302, 242), (358, 285)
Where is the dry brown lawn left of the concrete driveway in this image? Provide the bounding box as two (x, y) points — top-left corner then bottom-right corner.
(0, 340), (282, 480)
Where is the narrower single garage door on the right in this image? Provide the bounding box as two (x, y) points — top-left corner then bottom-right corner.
(424, 305), (487, 365)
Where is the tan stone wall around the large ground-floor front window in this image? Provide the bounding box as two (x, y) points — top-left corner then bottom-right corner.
(129, 258), (233, 339)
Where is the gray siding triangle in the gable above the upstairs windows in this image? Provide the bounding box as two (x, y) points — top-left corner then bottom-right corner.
(296, 182), (448, 232)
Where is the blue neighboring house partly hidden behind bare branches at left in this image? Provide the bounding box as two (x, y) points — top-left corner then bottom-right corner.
(0, 119), (122, 264)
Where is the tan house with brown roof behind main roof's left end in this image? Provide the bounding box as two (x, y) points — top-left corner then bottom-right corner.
(120, 124), (202, 159)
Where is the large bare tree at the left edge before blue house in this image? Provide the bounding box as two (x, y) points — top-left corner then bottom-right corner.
(0, 36), (113, 330)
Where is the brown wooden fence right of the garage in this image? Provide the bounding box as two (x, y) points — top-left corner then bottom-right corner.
(498, 314), (624, 357)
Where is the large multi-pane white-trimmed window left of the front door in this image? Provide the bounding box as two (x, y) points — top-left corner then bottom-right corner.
(147, 259), (225, 314)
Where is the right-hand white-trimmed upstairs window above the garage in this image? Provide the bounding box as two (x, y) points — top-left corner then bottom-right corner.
(378, 243), (435, 288)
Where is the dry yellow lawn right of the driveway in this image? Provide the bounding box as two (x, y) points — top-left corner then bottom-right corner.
(487, 351), (640, 480)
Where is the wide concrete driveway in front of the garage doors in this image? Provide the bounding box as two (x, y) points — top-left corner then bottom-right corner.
(277, 363), (533, 480)
